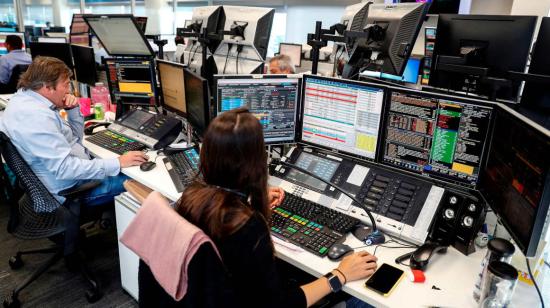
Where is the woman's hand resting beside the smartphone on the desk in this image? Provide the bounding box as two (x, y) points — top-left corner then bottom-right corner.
(333, 251), (378, 284)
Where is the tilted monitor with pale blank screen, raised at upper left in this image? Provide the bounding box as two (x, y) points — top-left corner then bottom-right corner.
(83, 14), (154, 57)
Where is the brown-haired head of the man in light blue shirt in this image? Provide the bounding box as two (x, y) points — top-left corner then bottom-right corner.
(17, 57), (72, 108)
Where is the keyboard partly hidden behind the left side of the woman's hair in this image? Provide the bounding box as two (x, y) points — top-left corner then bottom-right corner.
(163, 148), (199, 192)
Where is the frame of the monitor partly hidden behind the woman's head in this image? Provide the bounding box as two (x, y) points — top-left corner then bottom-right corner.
(212, 74), (303, 145)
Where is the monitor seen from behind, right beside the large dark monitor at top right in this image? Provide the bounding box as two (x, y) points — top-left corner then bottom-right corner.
(343, 3), (432, 78)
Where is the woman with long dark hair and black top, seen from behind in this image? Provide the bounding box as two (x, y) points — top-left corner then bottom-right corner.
(176, 108), (376, 307)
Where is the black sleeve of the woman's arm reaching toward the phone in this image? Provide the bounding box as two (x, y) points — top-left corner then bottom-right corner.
(222, 215), (307, 307)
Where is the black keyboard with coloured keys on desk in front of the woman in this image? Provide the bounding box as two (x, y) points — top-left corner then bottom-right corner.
(270, 194), (359, 257)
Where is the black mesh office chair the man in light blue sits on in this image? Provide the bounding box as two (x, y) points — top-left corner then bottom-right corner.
(0, 132), (102, 308)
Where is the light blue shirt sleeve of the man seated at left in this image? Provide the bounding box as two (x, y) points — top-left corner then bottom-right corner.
(10, 110), (120, 180)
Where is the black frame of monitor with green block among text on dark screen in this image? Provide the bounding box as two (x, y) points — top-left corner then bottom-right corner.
(378, 86), (497, 190)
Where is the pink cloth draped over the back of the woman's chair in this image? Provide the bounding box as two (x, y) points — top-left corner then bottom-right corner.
(120, 191), (221, 301)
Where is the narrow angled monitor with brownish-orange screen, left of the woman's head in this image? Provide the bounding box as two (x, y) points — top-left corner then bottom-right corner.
(157, 60), (187, 118)
